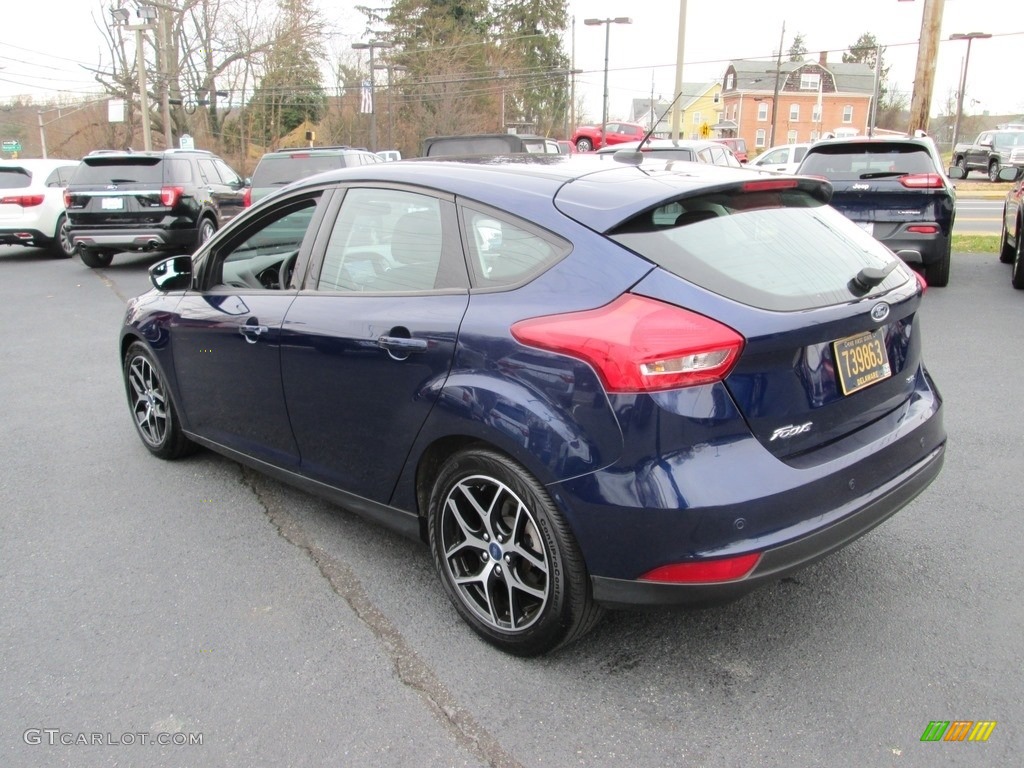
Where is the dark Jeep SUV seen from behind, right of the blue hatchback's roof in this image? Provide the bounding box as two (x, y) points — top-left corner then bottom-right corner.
(797, 136), (956, 287)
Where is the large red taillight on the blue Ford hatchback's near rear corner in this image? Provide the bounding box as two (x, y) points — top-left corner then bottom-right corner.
(512, 294), (743, 392)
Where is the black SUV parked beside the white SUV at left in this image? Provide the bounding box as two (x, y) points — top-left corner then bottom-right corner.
(65, 150), (246, 267)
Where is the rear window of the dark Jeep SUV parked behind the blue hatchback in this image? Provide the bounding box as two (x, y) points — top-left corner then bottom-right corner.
(800, 143), (939, 181)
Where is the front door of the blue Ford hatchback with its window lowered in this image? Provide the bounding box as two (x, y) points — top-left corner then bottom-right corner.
(169, 191), (323, 467)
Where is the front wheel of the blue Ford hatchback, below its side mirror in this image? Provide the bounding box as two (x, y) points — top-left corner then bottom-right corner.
(123, 341), (196, 459)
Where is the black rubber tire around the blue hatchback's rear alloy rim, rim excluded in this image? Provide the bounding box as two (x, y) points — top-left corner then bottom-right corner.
(427, 449), (570, 655)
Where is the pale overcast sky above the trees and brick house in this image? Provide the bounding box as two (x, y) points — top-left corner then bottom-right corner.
(0, 0), (1024, 121)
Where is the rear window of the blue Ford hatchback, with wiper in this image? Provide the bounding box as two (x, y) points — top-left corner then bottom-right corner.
(609, 189), (908, 311)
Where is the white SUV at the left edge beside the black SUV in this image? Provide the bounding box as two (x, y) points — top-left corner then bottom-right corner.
(0, 160), (78, 258)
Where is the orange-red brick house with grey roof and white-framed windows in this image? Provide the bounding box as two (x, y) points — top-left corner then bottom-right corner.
(713, 53), (874, 153)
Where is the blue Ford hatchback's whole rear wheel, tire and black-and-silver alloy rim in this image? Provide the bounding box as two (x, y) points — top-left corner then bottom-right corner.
(428, 447), (602, 656)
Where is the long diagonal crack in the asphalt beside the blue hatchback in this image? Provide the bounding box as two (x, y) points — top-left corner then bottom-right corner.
(241, 467), (523, 768)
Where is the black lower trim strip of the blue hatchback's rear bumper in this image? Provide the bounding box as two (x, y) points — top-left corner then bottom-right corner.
(591, 443), (945, 607)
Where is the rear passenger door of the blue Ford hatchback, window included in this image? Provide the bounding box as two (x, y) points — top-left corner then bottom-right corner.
(282, 186), (469, 503)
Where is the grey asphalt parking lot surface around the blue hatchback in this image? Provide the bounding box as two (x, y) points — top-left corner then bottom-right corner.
(0, 248), (1024, 768)
